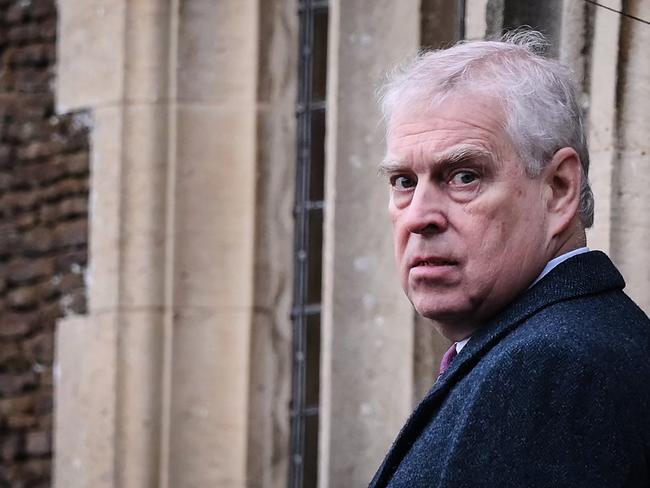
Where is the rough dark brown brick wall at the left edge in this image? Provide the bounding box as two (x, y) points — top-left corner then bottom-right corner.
(0, 0), (88, 488)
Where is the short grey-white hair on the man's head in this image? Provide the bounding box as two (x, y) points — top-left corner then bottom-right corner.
(380, 29), (594, 228)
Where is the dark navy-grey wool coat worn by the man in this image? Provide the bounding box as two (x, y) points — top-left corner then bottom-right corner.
(370, 251), (650, 488)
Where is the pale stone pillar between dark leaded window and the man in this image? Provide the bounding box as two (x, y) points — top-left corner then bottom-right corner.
(319, 0), (420, 487)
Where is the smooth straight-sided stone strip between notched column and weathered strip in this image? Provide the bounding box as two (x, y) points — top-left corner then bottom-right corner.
(166, 0), (258, 488)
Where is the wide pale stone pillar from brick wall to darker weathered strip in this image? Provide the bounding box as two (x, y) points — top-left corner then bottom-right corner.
(55, 0), (258, 488)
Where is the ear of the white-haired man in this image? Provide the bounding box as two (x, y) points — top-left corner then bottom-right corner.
(544, 147), (582, 237)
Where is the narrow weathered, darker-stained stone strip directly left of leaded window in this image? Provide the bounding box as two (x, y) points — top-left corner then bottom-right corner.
(247, 0), (298, 488)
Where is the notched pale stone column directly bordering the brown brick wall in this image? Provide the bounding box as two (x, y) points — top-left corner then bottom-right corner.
(54, 0), (170, 488)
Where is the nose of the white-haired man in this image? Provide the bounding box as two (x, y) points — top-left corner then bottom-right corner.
(404, 182), (449, 235)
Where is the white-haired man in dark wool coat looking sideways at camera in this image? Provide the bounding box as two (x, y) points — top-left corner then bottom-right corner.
(371, 32), (650, 488)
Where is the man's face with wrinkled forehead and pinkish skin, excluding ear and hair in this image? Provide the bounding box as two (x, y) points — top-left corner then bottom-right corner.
(383, 96), (551, 340)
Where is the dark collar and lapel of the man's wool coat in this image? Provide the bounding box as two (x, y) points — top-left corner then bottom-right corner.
(370, 251), (625, 488)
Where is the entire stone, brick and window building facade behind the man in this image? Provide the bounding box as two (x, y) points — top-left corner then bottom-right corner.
(0, 0), (650, 488)
